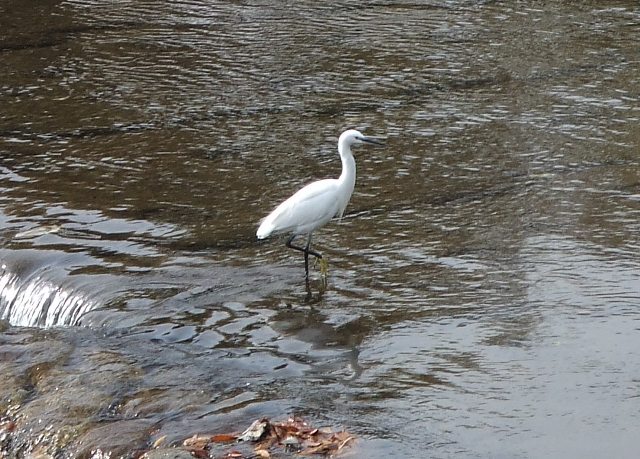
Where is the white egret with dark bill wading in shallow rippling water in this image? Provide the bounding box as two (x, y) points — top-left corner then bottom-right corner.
(256, 129), (383, 279)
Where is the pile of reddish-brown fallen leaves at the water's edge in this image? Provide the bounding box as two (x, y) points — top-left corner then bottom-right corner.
(183, 417), (355, 459)
